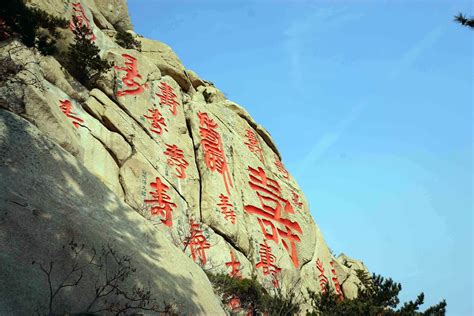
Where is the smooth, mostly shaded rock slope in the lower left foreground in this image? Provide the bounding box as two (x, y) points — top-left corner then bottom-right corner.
(0, 110), (223, 315)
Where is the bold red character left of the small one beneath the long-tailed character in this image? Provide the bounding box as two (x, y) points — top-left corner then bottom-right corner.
(145, 177), (176, 227)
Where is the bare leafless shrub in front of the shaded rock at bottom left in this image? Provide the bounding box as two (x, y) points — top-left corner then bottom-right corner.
(33, 240), (177, 315)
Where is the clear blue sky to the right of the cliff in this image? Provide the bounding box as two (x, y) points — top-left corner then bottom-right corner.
(128, 0), (474, 315)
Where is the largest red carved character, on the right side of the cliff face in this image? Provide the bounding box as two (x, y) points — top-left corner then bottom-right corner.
(244, 167), (303, 268)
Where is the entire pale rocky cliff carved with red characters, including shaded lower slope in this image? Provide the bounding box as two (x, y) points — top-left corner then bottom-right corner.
(0, 0), (366, 314)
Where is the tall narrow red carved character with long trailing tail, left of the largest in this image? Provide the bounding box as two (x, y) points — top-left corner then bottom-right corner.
(197, 112), (233, 194)
